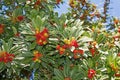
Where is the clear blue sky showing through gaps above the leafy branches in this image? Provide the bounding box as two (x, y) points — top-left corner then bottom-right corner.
(55, 0), (120, 18)
